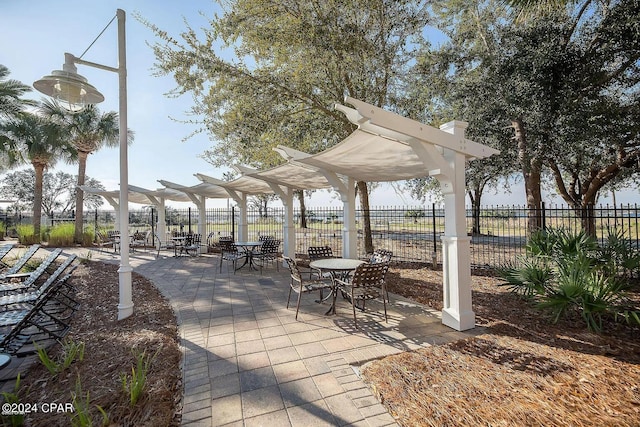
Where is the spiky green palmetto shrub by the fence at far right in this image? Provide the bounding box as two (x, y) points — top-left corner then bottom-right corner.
(498, 229), (640, 332)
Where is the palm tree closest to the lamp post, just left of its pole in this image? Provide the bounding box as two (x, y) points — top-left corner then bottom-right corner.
(42, 101), (133, 243)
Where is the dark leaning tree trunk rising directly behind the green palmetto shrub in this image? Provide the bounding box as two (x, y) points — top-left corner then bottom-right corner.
(511, 119), (542, 234)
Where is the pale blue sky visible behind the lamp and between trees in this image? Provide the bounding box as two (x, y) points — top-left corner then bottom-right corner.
(0, 0), (638, 206)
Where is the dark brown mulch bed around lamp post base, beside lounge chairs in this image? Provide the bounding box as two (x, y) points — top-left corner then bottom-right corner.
(13, 262), (182, 427)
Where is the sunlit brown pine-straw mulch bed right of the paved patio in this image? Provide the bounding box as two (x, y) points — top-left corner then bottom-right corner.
(362, 265), (640, 427)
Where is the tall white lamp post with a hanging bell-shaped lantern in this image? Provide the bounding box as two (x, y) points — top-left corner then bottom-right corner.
(33, 9), (133, 320)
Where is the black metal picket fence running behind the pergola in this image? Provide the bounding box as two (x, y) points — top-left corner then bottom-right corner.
(0, 204), (640, 267)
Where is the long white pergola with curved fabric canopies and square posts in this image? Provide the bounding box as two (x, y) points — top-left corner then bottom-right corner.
(87, 97), (498, 331)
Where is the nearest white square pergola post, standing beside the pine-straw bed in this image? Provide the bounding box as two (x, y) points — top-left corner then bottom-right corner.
(440, 121), (475, 331)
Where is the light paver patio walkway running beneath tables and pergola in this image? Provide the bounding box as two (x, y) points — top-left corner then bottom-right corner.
(85, 250), (480, 426)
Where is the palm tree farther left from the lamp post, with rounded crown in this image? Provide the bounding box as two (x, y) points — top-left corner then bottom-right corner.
(1, 112), (76, 238)
